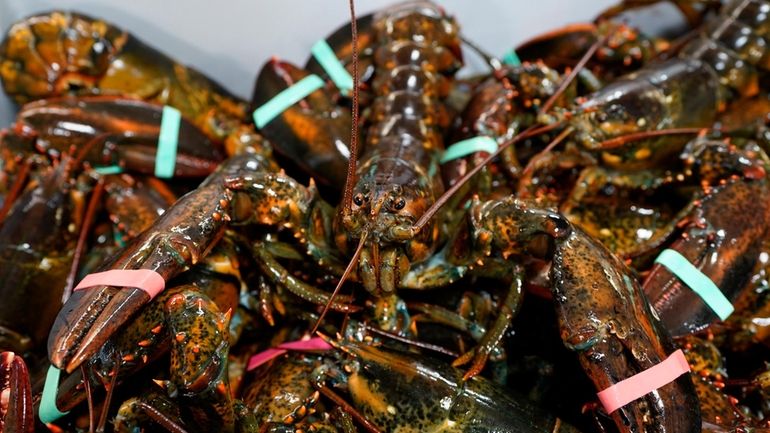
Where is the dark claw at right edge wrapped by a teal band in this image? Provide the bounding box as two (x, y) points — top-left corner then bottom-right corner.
(643, 179), (770, 337)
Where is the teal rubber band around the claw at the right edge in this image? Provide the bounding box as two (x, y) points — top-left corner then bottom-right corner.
(655, 250), (735, 320)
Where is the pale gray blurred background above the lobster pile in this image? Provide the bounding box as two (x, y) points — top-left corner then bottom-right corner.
(0, 0), (616, 127)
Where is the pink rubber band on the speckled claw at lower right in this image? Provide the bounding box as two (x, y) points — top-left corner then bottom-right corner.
(597, 349), (690, 414)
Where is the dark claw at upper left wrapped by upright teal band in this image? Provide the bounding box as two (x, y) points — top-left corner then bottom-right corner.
(16, 96), (224, 177)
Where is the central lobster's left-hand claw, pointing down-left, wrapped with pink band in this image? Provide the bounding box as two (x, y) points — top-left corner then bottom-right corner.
(48, 154), (271, 373)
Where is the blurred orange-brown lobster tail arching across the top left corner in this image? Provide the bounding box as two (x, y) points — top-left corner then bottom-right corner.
(0, 11), (246, 142)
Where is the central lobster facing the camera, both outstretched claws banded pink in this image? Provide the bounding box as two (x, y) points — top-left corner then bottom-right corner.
(12, 1), (760, 430)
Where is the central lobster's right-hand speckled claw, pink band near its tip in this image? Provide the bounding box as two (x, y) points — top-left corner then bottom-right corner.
(472, 198), (701, 432)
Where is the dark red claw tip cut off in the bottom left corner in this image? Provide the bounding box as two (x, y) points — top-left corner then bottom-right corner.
(0, 352), (35, 433)
